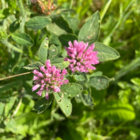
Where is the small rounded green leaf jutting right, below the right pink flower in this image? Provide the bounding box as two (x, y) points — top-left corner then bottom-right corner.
(89, 76), (110, 90)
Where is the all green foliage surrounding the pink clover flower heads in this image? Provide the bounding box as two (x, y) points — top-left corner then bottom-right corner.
(0, 0), (140, 140)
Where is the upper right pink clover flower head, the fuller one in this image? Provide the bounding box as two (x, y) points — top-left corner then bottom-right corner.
(65, 40), (99, 73)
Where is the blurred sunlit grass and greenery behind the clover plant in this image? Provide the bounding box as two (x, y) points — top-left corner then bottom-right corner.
(0, 0), (140, 140)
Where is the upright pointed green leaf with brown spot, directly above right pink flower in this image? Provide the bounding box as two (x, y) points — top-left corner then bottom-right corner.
(78, 11), (100, 44)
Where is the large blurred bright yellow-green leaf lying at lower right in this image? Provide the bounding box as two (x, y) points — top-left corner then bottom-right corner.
(94, 100), (135, 121)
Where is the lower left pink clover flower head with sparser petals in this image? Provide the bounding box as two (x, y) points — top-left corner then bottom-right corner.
(32, 60), (69, 100)
